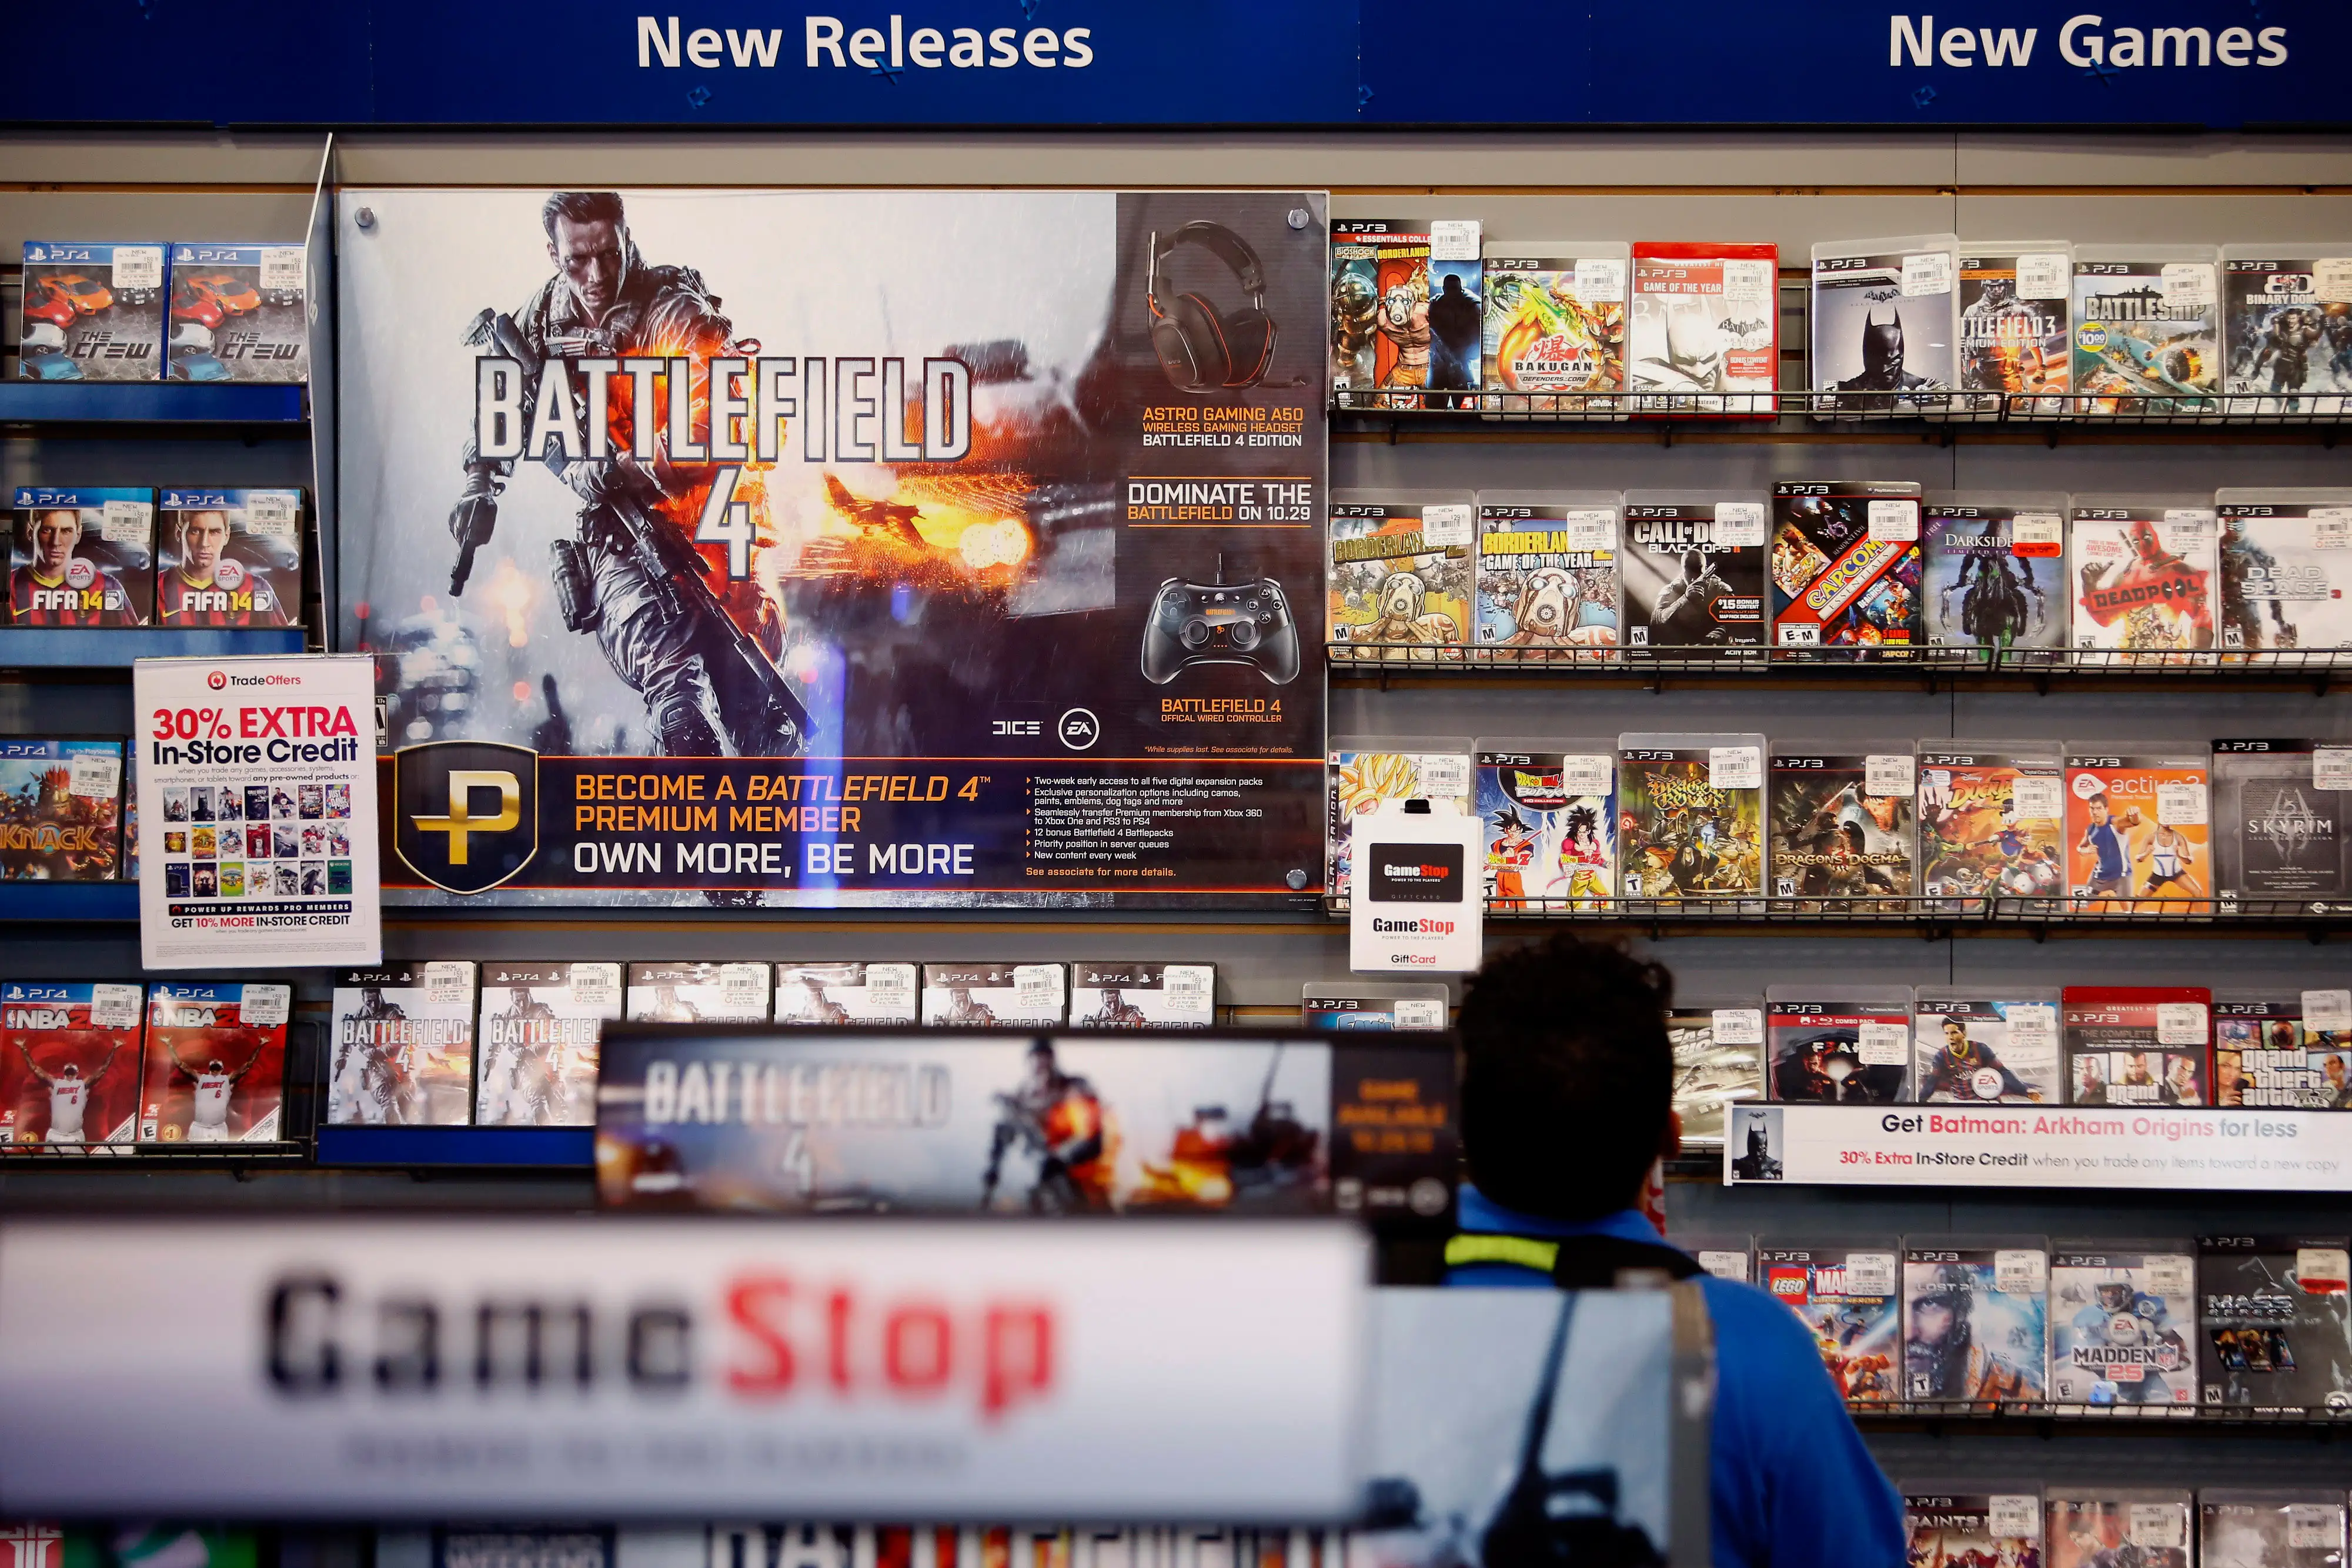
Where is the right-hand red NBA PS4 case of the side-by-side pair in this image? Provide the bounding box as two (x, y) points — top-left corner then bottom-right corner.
(139, 980), (294, 1142)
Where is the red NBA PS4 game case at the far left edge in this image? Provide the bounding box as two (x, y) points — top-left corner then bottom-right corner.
(0, 980), (143, 1147)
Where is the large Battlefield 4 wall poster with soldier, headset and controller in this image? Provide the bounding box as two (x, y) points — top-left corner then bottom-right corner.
(339, 188), (1327, 907)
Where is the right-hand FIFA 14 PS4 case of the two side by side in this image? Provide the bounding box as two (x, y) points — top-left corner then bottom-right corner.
(155, 489), (303, 626)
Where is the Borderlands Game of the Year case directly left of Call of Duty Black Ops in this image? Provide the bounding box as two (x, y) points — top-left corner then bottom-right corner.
(1475, 489), (1623, 666)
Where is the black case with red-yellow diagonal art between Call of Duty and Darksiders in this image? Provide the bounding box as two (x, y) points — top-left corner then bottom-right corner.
(1771, 480), (1922, 663)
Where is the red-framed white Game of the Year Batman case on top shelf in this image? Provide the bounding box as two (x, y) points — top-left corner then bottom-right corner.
(1625, 240), (1780, 419)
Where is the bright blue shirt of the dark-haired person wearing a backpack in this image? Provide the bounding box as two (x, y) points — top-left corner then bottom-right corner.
(1446, 1185), (1905, 1568)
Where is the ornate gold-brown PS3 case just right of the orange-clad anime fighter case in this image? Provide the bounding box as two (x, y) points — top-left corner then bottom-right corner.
(1618, 731), (1764, 902)
